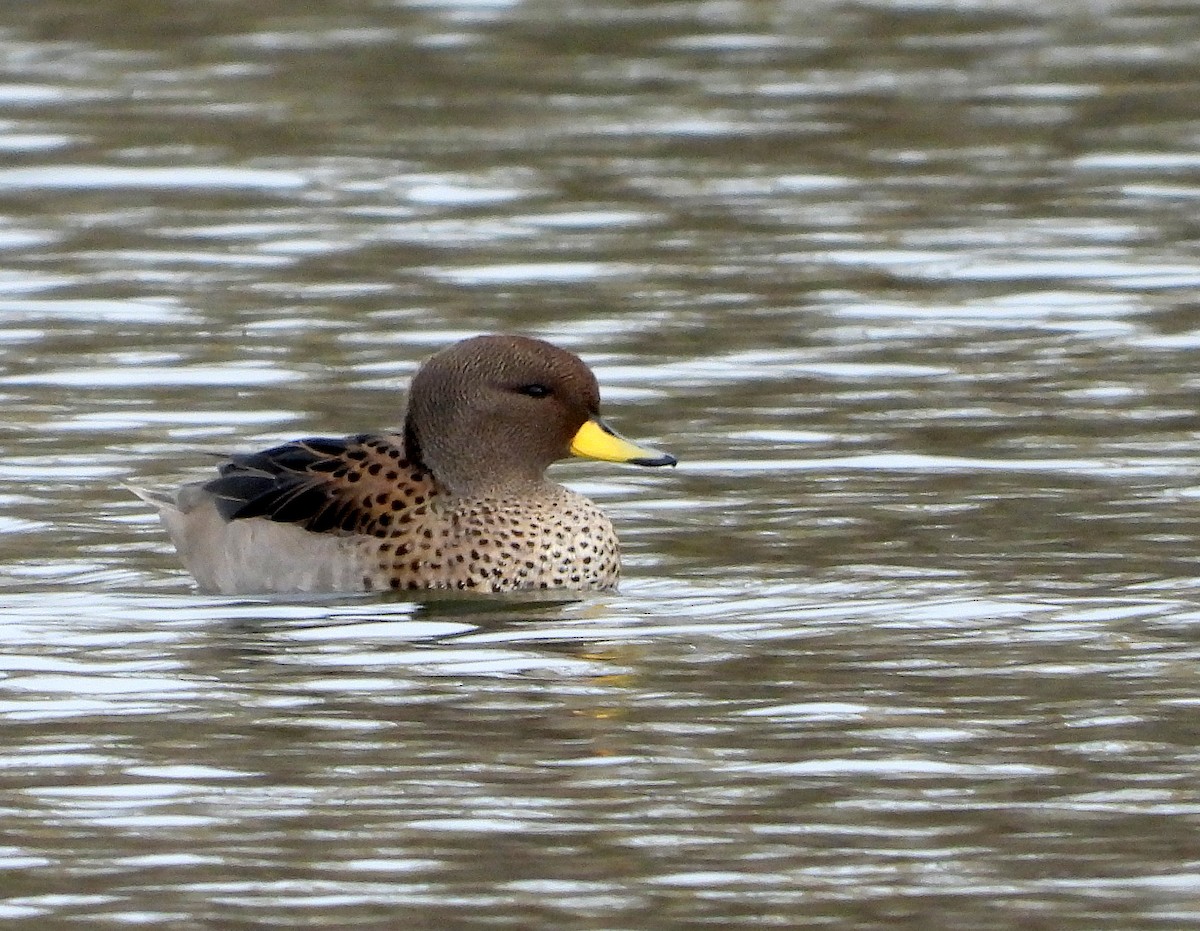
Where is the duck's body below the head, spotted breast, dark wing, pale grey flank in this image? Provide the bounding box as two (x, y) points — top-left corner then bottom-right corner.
(131, 434), (620, 594)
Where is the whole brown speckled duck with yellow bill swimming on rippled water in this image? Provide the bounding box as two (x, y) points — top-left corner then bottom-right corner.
(130, 334), (677, 596)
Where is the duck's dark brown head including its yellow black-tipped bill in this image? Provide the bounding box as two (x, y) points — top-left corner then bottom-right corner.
(404, 336), (676, 495)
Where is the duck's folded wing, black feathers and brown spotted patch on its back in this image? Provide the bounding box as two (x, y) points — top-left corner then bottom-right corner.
(203, 433), (437, 536)
